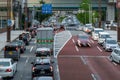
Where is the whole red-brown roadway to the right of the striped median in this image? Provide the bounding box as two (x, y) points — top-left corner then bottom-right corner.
(58, 31), (120, 80)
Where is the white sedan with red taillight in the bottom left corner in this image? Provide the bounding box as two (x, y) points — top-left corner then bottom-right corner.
(0, 58), (17, 78)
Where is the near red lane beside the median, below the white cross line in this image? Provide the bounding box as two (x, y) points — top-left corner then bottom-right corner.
(58, 56), (93, 80)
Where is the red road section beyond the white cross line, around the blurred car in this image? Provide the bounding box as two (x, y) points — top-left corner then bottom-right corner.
(59, 36), (110, 56)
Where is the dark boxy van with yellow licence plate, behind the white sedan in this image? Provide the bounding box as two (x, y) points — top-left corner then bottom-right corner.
(4, 43), (20, 61)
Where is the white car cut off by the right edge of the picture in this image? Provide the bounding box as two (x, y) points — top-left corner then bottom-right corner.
(110, 48), (120, 63)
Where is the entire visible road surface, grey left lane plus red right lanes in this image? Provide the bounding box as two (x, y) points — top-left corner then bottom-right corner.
(0, 31), (120, 80)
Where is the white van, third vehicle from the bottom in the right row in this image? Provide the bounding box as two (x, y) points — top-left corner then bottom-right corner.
(98, 32), (110, 45)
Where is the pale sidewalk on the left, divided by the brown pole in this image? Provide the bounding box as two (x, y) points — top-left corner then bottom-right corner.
(0, 30), (25, 51)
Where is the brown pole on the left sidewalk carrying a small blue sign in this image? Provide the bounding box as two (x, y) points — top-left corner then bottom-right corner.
(7, 0), (11, 42)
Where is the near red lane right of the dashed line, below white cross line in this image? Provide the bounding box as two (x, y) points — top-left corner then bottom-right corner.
(86, 57), (120, 80)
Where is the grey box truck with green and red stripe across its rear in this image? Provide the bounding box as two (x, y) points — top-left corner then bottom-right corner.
(36, 27), (54, 50)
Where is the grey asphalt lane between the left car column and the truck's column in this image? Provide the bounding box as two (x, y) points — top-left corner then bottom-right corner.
(12, 40), (35, 80)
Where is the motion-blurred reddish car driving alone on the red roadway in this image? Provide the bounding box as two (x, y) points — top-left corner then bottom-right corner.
(76, 34), (91, 47)
